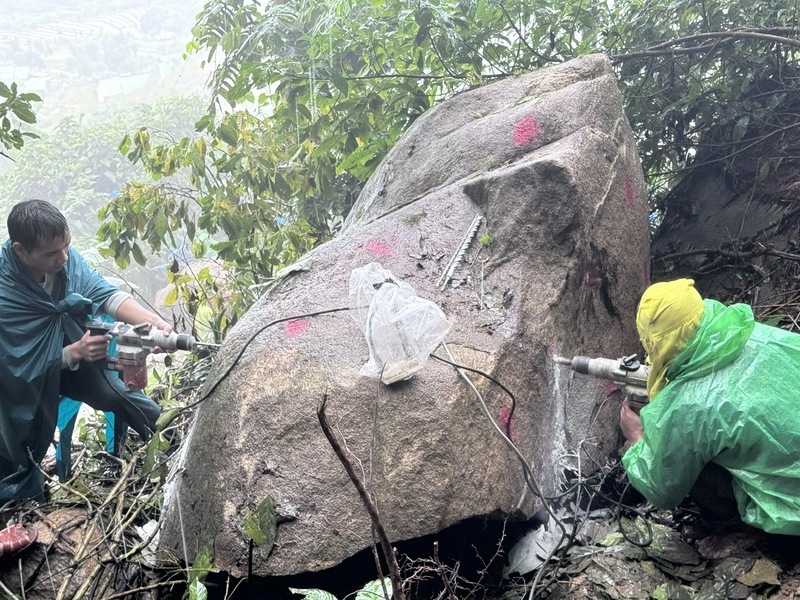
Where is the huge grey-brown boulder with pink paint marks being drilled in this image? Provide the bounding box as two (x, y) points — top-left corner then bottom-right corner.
(156, 56), (649, 576)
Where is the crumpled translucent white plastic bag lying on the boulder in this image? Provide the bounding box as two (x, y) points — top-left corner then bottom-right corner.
(350, 263), (452, 385)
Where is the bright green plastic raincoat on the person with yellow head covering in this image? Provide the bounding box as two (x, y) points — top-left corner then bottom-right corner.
(622, 299), (800, 535)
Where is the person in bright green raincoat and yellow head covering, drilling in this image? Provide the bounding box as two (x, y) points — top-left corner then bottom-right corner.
(620, 279), (800, 535)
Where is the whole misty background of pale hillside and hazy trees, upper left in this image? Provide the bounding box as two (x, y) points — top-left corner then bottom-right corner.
(0, 0), (210, 299)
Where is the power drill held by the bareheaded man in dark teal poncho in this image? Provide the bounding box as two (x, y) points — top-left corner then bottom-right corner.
(86, 321), (217, 390)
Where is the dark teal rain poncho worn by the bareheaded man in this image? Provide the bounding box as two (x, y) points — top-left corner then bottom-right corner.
(0, 241), (119, 503)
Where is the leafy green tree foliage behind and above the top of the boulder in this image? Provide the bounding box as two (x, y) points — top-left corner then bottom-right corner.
(101, 0), (800, 338)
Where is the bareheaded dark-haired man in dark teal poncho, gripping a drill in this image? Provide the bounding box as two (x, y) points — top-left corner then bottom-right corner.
(0, 200), (172, 504)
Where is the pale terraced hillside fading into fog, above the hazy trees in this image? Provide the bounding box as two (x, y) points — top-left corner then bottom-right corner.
(0, 0), (206, 129)
